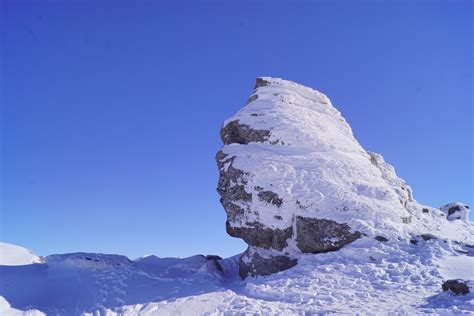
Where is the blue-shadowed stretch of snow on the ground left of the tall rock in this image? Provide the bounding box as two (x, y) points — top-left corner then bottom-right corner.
(0, 253), (231, 315)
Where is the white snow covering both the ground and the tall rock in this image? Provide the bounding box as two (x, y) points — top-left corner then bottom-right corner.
(0, 78), (474, 315)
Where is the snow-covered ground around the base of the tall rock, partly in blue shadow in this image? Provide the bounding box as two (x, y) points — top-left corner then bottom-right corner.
(0, 239), (474, 315)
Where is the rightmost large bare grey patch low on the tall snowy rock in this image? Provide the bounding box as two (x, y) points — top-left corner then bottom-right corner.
(296, 216), (362, 253)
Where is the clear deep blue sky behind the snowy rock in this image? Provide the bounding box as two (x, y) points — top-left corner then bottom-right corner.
(0, 0), (474, 258)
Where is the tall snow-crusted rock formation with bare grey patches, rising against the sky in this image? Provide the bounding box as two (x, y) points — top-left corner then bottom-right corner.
(216, 77), (468, 278)
